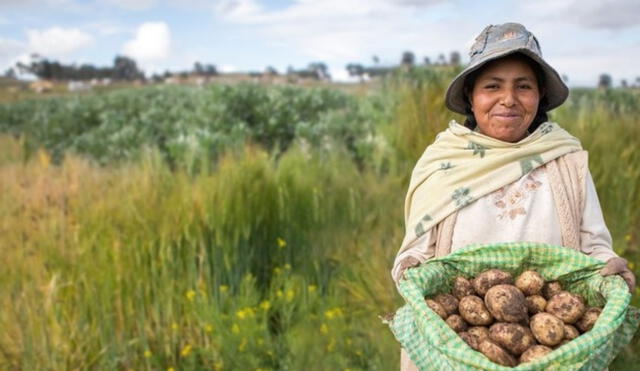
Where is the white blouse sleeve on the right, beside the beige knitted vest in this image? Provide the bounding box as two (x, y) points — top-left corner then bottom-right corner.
(580, 172), (618, 262)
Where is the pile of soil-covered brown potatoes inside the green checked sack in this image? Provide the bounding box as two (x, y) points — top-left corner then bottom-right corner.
(425, 269), (602, 367)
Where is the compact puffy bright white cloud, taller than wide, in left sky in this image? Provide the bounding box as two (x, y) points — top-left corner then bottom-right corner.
(122, 22), (171, 65)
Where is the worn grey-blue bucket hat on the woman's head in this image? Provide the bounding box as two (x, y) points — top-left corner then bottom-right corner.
(445, 23), (569, 114)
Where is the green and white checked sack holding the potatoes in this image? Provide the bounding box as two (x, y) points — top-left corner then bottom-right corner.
(386, 243), (640, 370)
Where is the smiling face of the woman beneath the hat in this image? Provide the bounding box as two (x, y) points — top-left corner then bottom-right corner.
(470, 57), (540, 143)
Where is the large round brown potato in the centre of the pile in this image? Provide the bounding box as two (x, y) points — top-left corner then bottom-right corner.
(484, 284), (527, 322)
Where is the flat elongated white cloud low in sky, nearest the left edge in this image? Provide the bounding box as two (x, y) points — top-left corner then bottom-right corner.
(27, 27), (94, 58)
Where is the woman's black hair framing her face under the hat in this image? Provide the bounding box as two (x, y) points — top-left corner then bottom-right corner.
(463, 53), (549, 132)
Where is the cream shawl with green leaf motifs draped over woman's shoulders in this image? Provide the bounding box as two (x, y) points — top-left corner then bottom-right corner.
(398, 121), (582, 253)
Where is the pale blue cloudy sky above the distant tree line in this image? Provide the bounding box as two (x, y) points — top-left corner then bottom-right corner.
(0, 0), (640, 86)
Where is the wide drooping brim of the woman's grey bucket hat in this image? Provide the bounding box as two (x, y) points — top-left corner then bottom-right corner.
(445, 48), (569, 115)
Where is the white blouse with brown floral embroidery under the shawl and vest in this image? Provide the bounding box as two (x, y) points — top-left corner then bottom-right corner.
(391, 166), (617, 282)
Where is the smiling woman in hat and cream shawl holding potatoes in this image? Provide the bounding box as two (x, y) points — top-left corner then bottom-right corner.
(392, 23), (635, 370)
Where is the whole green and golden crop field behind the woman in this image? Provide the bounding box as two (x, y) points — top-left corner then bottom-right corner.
(0, 69), (640, 370)
